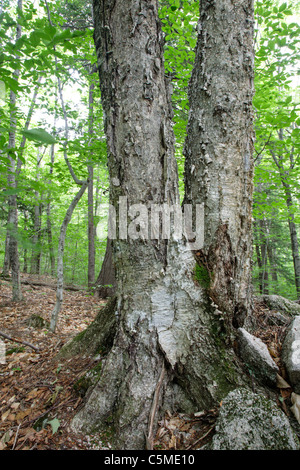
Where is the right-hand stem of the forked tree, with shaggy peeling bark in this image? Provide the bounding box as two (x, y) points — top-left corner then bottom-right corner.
(185, 0), (254, 326)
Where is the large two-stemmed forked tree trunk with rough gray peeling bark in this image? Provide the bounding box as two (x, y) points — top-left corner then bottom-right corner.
(72, 0), (253, 449)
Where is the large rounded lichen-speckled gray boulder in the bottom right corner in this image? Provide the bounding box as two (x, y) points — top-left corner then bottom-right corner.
(208, 389), (300, 450)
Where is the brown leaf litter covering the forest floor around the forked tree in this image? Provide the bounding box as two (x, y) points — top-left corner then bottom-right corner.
(0, 274), (291, 450)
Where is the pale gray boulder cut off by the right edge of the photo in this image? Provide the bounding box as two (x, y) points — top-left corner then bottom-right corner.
(281, 315), (300, 394)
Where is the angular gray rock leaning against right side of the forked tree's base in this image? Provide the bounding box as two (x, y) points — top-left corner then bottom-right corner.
(237, 328), (279, 386)
